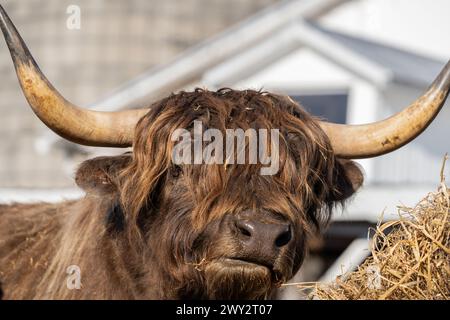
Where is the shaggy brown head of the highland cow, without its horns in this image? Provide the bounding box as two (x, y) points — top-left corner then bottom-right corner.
(73, 89), (362, 298)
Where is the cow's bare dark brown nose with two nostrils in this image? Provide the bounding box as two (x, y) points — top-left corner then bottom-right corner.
(234, 214), (292, 265)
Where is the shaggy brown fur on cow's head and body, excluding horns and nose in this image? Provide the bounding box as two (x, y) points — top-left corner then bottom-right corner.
(0, 89), (362, 299)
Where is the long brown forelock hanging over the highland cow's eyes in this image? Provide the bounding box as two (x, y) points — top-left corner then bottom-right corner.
(121, 89), (342, 240)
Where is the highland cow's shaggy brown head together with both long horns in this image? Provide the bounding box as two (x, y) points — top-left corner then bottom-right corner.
(0, 8), (450, 298)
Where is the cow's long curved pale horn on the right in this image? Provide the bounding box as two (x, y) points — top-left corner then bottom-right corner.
(320, 61), (450, 159)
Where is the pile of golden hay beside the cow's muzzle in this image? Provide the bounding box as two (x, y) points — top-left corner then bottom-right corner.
(310, 160), (450, 300)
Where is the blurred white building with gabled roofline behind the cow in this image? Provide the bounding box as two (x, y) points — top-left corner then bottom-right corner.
(49, 0), (450, 221)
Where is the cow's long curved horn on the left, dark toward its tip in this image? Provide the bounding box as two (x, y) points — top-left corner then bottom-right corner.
(0, 6), (149, 147)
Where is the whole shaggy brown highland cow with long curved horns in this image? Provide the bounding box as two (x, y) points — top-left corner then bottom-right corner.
(0, 7), (450, 299)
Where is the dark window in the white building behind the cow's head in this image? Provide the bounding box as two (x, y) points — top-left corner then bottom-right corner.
(290, 94), (348, 123)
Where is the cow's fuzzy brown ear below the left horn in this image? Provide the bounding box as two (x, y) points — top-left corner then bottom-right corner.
(75, 154), (131, 195)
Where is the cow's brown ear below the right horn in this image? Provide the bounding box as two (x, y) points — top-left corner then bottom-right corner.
(332, 159), (364, 201)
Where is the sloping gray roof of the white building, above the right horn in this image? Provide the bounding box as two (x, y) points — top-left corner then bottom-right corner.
(309, 22), (445, 86)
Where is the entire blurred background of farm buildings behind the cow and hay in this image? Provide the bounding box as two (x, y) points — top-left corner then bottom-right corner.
(0, 0), (450, 298)
